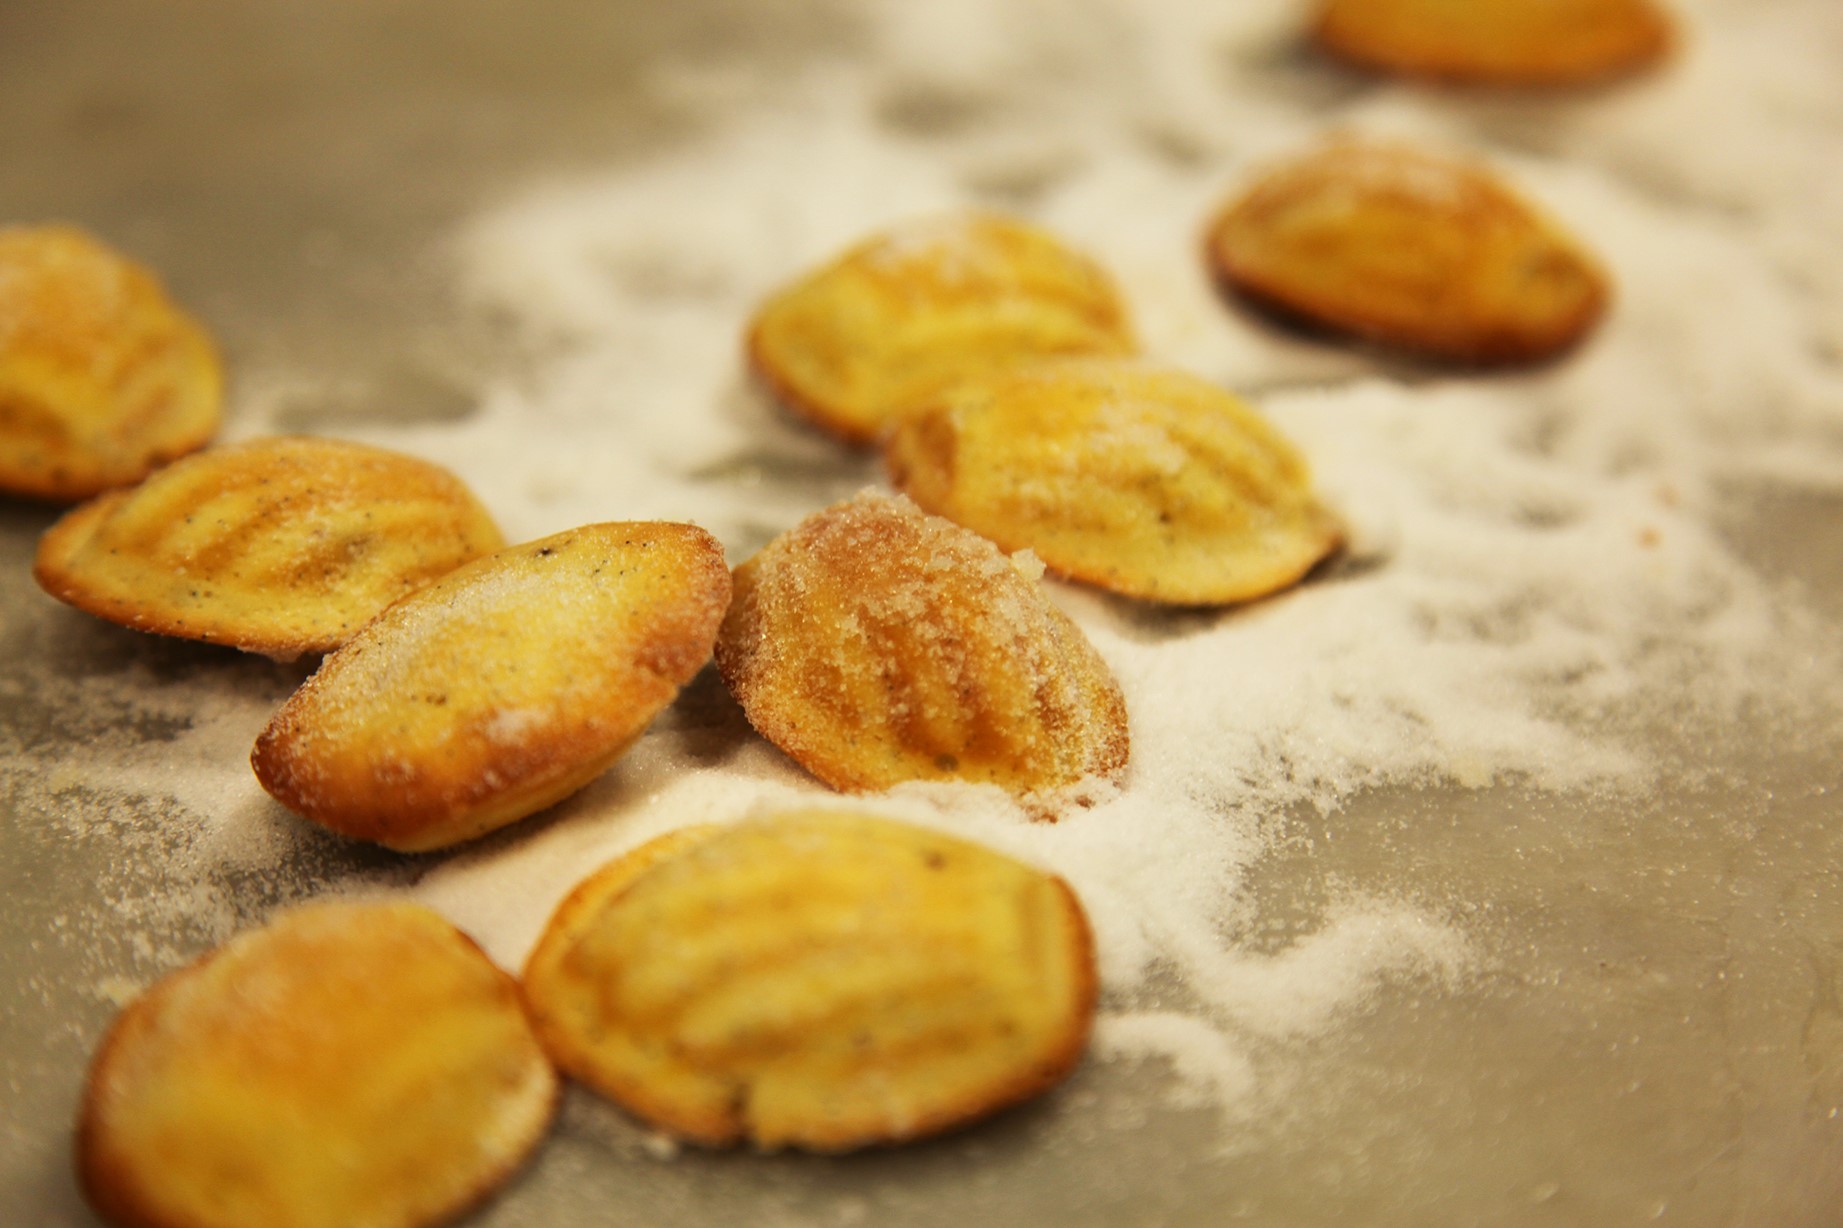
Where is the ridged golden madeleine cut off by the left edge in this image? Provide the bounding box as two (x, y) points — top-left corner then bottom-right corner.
(0, 225), (223, 503)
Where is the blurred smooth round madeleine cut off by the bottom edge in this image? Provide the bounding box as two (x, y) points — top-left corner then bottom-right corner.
(76, 903), (558, 1228)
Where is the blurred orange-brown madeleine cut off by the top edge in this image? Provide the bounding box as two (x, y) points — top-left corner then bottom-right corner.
(1314, 0), (1672, 87)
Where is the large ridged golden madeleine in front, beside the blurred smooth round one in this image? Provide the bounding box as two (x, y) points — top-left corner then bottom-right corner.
(525, 811), (1095, 1151)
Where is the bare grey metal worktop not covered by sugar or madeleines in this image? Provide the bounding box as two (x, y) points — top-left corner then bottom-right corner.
(0, 0), (1843, 1228)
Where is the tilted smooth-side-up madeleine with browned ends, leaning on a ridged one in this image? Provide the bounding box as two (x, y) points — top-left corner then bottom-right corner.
(251, 522), (730, 852)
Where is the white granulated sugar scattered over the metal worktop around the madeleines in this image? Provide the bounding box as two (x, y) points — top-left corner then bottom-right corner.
(7, 0), (1843, 1150)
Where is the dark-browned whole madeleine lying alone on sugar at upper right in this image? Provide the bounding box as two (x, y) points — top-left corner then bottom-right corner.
(1205, 140), (1609, 363)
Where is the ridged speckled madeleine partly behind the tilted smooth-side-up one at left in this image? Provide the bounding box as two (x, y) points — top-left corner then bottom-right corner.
(33, 437), (503, 660)
